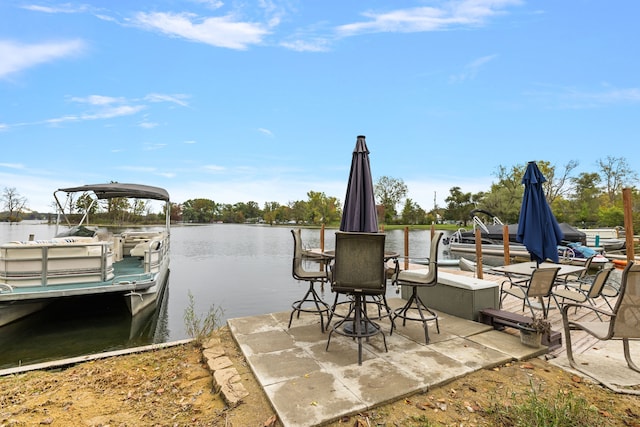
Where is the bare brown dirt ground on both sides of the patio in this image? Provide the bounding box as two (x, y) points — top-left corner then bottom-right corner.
(0, 327), (640, 427)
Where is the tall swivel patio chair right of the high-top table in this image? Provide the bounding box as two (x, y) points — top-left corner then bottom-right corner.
(391, 231), (443, 344)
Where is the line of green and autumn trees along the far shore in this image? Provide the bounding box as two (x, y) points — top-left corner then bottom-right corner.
(0, 156), (640, 230)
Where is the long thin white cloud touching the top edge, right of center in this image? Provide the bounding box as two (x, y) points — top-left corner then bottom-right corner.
(337, 0), (522, 36)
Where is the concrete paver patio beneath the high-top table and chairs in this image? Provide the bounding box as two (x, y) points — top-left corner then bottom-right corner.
(228, 298), (547, 427)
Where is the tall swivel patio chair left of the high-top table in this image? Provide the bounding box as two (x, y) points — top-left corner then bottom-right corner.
(289, 228), (329, 333)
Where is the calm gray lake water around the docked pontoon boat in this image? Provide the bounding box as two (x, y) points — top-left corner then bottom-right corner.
(0, 222), (446, 368)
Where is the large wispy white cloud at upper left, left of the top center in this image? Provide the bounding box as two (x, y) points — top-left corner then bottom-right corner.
(134, 12), (269, 50)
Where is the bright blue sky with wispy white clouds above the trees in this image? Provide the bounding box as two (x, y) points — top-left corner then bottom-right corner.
(0, 0), (640, 211)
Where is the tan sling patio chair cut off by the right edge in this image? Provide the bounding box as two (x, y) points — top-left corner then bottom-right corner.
(562, 261), (640, 395)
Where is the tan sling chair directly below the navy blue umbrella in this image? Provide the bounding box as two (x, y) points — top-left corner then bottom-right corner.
(500, 267), (560, 319)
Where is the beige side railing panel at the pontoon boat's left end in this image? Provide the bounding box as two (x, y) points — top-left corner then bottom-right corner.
(0, 239), (114, 287)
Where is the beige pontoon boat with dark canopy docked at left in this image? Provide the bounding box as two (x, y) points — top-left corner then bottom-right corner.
(0, 183), (171, 326)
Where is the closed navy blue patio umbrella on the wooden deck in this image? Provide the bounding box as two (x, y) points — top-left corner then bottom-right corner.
(516, 162), (564, 264)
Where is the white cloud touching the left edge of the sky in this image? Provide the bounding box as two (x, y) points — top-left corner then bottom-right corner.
(0, 40), (86, 78)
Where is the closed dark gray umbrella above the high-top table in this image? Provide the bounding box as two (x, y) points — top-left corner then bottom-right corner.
(340, 135), (378, 233)
